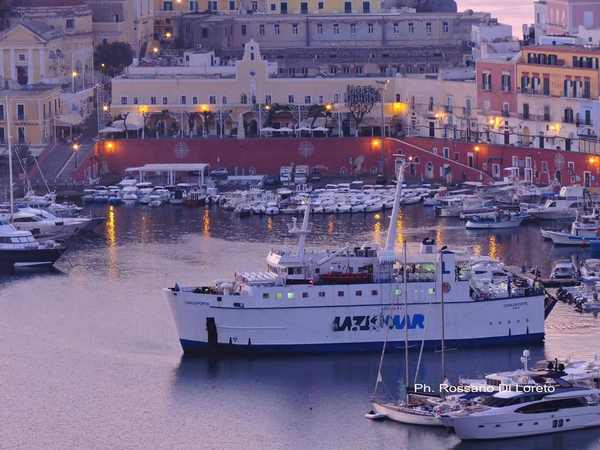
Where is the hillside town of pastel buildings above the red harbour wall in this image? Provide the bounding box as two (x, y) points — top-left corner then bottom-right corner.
(0, 0), (600, 183)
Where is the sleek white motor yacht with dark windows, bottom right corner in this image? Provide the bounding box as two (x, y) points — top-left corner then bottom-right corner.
(440, 386), (600, 440)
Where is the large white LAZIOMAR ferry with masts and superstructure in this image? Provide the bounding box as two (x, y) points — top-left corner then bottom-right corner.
(163, 160), (556, 353)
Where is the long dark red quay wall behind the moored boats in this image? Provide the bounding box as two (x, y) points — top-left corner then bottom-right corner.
(74, 137), (600, 187)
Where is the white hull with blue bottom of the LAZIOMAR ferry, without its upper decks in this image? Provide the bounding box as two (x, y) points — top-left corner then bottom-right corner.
(164, 285), (553, 353)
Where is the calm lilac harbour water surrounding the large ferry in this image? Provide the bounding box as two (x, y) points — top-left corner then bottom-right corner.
(0, 206), (600, 450)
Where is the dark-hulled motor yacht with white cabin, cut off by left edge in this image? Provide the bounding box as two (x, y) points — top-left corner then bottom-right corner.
(0, 220), (65, 271)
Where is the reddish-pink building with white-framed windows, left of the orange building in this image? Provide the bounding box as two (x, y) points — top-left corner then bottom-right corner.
(476, 59), (517, 117)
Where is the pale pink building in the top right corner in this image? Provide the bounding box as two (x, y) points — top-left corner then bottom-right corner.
(545, 0), (600, 34)
